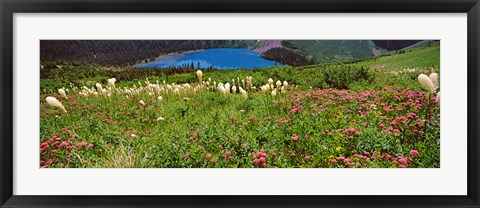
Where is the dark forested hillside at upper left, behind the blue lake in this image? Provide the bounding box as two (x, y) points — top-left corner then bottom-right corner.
(40, 40), (254, 66)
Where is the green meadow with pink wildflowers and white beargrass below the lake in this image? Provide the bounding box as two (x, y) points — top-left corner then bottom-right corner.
(39, 41), (441, 168)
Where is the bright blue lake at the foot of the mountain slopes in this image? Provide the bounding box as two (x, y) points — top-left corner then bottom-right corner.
(136, 48), (281, 69)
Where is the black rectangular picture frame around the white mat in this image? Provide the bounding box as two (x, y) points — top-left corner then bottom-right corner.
(0, 0), (480, 207)
